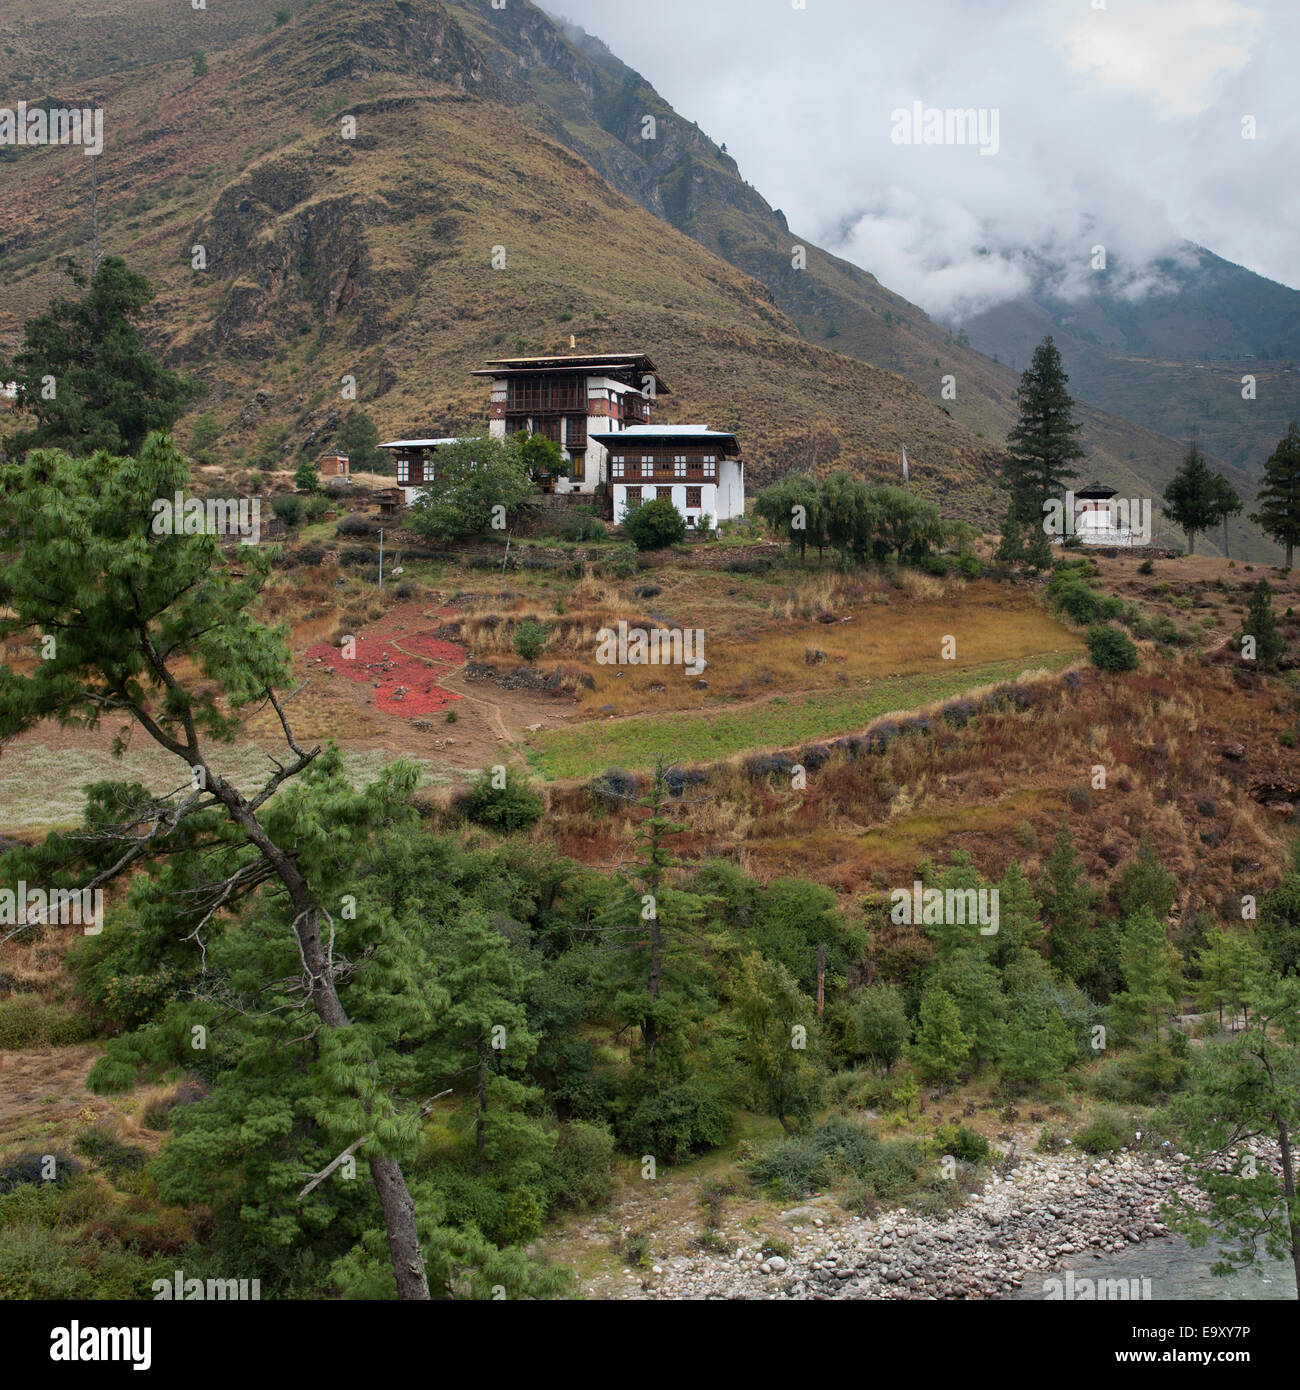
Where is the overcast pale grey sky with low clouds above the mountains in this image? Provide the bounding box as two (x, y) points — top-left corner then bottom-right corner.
(545, 0), (1300, 320)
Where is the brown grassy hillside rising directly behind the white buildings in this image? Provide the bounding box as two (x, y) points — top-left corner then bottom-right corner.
(0, 0), (996, 518)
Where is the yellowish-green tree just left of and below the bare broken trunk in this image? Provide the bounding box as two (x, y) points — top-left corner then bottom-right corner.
(731, 951), (824, 1134)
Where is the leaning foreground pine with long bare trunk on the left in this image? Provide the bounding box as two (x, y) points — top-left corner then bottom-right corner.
(0, 435), (428, 1298)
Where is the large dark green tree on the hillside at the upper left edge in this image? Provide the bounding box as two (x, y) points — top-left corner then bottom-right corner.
(0, 256), (203, 457)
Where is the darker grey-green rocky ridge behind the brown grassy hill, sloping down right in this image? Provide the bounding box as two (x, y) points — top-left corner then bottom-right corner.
(433, 0), (1272, 556)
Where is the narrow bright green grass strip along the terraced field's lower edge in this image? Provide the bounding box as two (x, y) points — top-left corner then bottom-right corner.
(527, 652), (1079, 781)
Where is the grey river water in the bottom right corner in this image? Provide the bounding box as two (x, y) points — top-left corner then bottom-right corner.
(1008, 1236), (1296, 1301)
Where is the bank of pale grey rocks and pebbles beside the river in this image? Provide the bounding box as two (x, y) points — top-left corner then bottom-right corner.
(587, 1150), (1294, 1300)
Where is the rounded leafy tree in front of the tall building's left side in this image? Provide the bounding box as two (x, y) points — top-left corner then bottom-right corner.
(409, 436), (535, 542)
